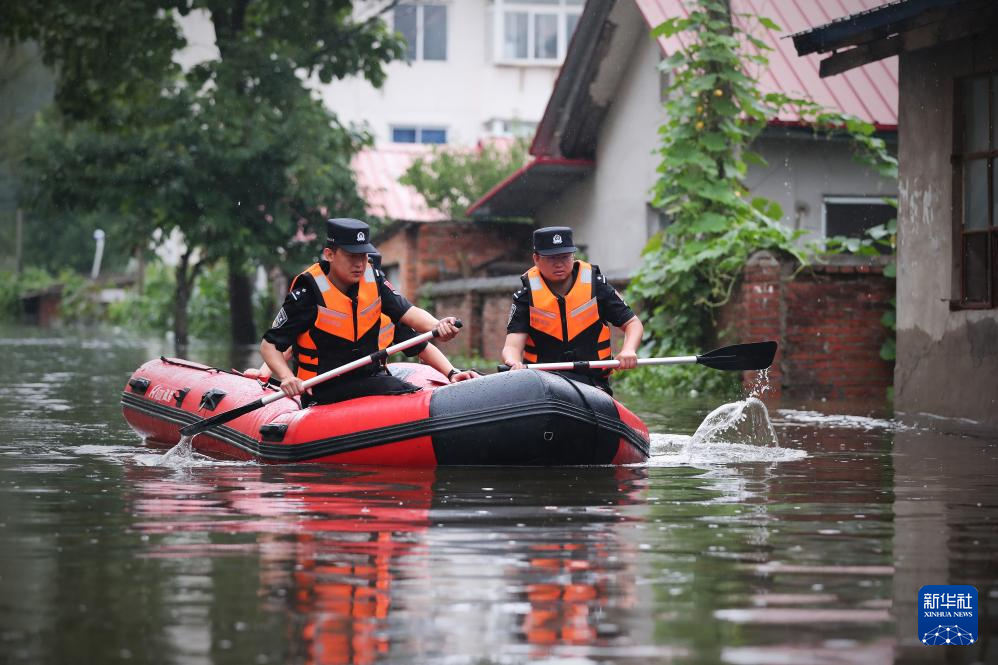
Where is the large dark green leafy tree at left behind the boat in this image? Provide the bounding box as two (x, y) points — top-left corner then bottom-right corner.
(0, 0), (403, 346)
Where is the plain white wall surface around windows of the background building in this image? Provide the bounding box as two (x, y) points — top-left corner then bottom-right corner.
(317, 0), (558, 145)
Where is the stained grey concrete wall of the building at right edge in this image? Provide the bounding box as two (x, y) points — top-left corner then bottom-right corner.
(894, 31), (998, 428)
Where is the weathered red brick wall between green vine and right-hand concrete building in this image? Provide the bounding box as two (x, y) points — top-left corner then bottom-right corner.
(718, 252), (894, 402)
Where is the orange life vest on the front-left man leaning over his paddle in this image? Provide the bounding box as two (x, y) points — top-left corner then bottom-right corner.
(292, 263), (382, 381)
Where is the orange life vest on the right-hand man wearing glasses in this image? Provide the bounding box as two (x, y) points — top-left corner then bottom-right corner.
(522, 261), (610, 363)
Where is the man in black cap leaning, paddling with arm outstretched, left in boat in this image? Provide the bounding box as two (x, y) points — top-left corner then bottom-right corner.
(260, 219), (458, 405)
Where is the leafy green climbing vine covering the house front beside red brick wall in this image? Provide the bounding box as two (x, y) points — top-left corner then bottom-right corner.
(628, 0), (897, 393)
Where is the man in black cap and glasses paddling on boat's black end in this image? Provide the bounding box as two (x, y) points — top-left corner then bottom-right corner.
(502, 226), (644, 392)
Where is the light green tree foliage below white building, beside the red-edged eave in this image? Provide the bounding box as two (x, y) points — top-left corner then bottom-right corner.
(399, 139), (529, 219)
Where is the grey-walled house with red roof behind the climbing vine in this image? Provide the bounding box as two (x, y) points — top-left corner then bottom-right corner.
(468, 0), (898, 275)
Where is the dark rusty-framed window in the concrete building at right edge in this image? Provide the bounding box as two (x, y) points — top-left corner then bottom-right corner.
(953, 74), (998, 308)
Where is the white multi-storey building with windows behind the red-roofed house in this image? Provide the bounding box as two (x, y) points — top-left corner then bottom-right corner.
(317, 0), (585, 145)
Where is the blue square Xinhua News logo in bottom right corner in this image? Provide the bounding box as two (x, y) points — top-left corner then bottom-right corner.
(918, 584), (978, 646)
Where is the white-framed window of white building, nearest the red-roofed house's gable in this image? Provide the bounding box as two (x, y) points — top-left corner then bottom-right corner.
(496, 0), (584, 64)
